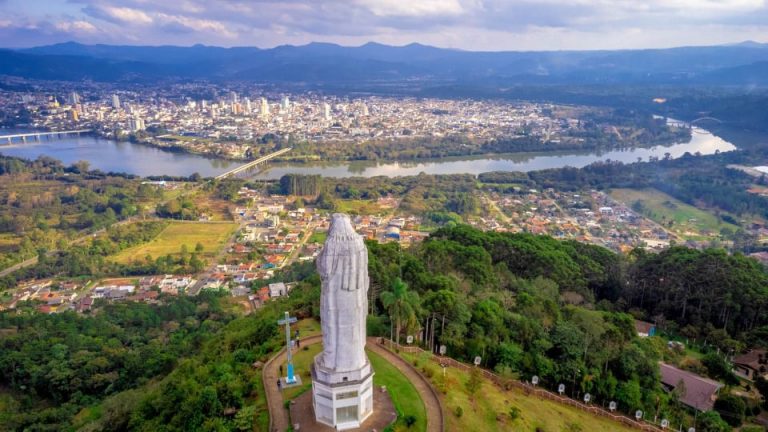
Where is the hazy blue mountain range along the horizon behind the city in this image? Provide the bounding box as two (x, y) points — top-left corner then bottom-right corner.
(0, 41), (768, 86)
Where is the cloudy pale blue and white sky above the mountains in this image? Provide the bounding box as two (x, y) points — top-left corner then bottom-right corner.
(0, 0), (768, 51)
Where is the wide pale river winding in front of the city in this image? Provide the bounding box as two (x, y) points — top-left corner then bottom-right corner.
(0, 128), (736, 180)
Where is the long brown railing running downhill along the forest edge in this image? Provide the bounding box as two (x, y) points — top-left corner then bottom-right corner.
(382, 339), (666, 432)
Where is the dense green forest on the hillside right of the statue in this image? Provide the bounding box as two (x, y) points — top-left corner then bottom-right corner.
(369, 225), (768, 430)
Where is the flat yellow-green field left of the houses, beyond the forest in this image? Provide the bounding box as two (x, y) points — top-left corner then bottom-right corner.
(112, 222), (237, 263)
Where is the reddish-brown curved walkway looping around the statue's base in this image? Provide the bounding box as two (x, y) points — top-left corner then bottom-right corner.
(261, 335), (445, 432)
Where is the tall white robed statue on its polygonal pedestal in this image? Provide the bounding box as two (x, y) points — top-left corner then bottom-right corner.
(312, 213), (374, 430)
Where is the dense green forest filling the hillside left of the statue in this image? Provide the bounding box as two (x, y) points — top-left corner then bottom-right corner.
(0, 277), (319, 431)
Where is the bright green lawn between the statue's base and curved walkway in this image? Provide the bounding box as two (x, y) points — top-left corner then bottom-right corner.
(283, 338), (427, 431)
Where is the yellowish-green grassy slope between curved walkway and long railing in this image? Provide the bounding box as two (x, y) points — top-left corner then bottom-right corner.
(403, 354), (635, 432)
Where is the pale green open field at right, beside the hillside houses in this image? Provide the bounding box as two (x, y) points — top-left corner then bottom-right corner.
(610, 189), (738, 239)
